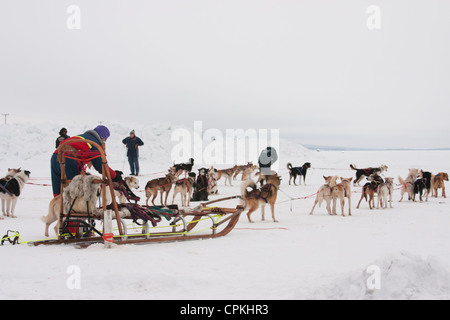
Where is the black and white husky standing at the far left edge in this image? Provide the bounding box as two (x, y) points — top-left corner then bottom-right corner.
(0, 170), (30, 219)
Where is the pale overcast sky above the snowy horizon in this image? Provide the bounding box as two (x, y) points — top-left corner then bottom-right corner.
(0, 0), (450, 148)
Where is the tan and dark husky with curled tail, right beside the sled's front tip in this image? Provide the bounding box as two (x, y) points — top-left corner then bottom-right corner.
(241, 174), (281, 223)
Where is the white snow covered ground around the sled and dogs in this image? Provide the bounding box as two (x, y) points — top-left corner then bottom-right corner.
(0, 122), (450, 299)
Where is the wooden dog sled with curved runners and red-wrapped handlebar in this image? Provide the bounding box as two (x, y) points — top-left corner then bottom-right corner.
(28, 139), (245, 247)
